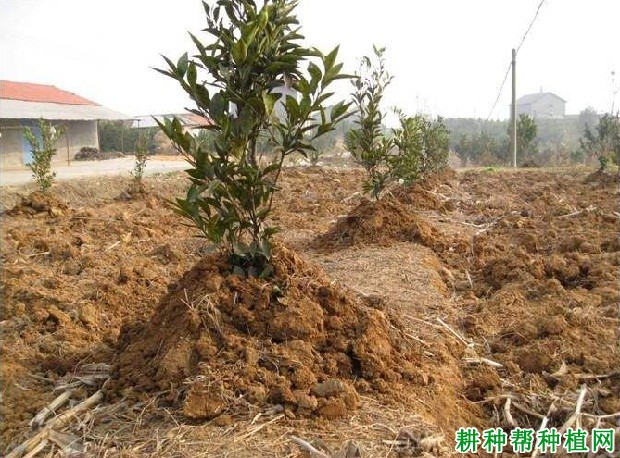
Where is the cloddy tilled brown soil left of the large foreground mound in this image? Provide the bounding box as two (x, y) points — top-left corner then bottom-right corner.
(0, 179), (202, 448)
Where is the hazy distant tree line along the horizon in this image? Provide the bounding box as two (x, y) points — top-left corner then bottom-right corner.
(99, 108), (620, 172)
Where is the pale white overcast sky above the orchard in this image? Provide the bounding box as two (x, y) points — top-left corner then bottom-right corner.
(0, 0), (620, 119)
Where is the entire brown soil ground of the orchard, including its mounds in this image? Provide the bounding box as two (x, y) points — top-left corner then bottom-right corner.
(0, 168), (620, 457)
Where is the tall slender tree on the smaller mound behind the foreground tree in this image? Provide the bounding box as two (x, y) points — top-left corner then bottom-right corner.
(345, 46), (393, 199)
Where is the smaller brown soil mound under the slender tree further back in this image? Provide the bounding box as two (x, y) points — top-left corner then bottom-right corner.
(313, 195), (450, 251)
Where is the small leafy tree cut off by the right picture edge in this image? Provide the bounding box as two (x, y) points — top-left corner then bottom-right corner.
(579, 113), (620, 170)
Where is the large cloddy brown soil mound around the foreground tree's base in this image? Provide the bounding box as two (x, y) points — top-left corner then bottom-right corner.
(117, 246), (421, 419)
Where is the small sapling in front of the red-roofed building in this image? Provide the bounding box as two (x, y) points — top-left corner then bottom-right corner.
(24, 119), (64, 192)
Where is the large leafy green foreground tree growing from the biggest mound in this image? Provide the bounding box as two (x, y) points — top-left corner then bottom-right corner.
(159, 0), (349, 278)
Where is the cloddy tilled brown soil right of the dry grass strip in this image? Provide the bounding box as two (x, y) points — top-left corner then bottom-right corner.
(439, 168), (620, 414)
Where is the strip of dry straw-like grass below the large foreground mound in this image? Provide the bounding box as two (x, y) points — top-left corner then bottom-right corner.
(80, 398), (439, 458)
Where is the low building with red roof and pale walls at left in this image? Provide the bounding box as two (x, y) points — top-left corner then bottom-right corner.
(0, 81), (129, 167)
